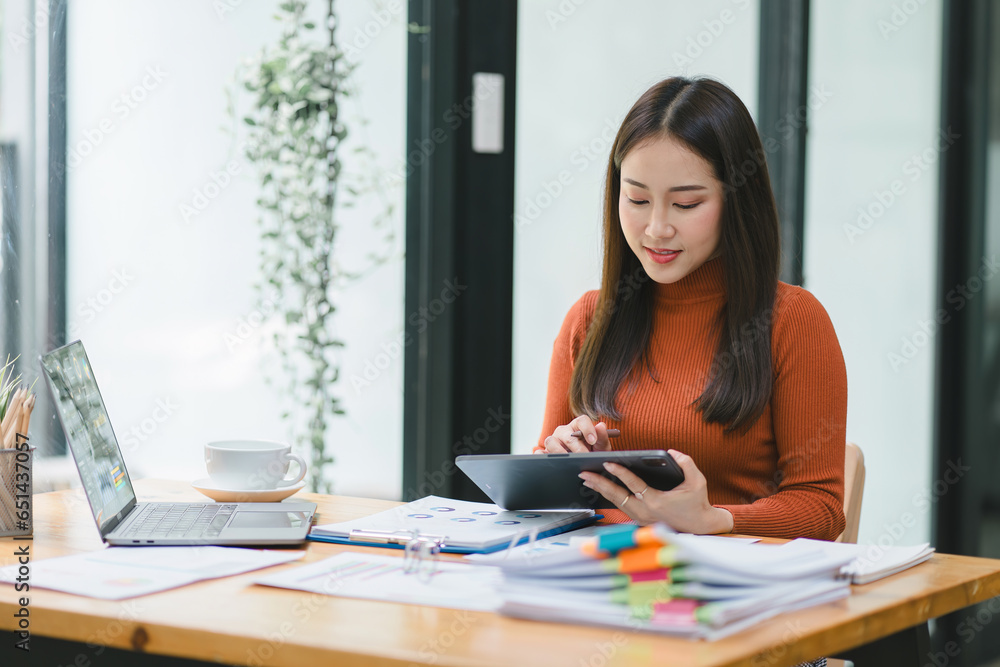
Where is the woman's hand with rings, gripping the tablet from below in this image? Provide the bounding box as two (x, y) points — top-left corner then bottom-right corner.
(580, 449), (733, 535)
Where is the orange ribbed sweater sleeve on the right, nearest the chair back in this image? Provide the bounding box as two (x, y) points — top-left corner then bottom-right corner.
(720, 288), (847, 540)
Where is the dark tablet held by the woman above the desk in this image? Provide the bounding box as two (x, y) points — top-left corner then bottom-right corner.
(455, 449), (684, 510)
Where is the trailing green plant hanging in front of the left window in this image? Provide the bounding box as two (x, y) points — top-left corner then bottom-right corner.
(239, 0), (394, 493)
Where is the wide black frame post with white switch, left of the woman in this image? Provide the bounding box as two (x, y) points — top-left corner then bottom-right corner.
(402, 0), (517, 500)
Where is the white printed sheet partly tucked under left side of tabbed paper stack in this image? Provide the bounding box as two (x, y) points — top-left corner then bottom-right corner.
(256, 553), (500, 611)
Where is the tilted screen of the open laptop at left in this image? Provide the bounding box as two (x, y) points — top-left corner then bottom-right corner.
(42, 341), (135, 535)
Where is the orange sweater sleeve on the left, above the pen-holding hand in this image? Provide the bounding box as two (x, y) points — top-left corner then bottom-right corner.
(534, 291), (598, 451)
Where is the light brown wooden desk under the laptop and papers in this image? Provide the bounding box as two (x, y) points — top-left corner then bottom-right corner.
(0, 480), (1000, 667)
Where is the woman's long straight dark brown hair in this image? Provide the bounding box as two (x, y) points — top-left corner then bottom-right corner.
(569, 77), (781, 431)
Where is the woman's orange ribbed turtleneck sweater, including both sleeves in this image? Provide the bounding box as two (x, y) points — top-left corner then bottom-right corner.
(539, 258), (847, 540)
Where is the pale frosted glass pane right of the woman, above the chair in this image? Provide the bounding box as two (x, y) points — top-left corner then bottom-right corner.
(805, 0), (947, 544)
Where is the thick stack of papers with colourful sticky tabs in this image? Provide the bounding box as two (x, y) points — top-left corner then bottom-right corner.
(479, 524), (856, 638)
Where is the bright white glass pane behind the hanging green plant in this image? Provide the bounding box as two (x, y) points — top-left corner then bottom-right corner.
(67, 0), (406, 498)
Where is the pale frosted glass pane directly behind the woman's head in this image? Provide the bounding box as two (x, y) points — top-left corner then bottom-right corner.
(511, 0), (759, 453)
